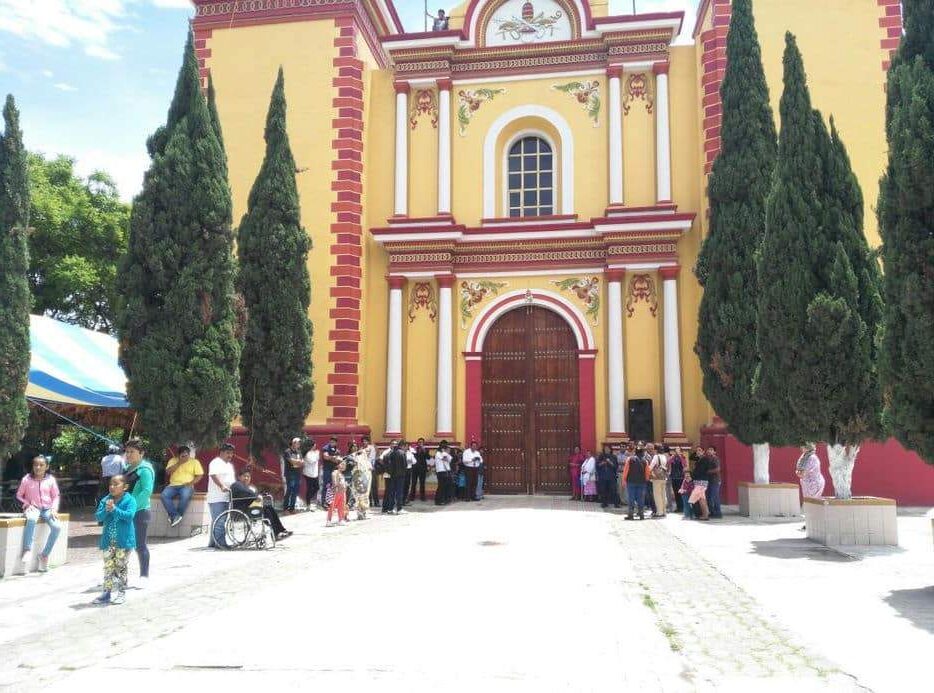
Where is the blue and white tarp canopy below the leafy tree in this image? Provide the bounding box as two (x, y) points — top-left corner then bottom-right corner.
(26, 315), (130, 409)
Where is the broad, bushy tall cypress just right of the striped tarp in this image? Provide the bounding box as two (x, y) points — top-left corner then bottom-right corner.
(117, 33), (240, 454)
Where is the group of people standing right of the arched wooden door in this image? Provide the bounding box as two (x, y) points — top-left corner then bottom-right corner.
(568, 442), (723, 521)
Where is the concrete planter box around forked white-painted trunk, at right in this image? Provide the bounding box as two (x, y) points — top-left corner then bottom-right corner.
(804, 496), (898, 546)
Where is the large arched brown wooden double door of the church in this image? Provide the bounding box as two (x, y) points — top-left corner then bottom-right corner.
(481, 306), (580, 494)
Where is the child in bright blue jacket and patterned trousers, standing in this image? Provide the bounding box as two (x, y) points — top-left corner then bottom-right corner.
(94, 474), (136, 605)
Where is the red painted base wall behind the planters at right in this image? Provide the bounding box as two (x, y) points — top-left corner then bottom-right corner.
(701, 428), (934, 506)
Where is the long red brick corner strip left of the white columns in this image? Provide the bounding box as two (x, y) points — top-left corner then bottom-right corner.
(327, 15), (363, 425)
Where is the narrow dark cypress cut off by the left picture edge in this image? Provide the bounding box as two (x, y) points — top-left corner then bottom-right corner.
(0, 94), (32, 469)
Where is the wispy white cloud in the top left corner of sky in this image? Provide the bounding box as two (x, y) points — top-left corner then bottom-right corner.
(0, 0), (127, 60)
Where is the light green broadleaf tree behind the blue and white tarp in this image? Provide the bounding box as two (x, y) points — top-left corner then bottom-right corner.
(28, 154), (130, 332)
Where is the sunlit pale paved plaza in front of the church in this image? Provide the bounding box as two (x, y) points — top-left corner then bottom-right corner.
(0, 497), (934, 692)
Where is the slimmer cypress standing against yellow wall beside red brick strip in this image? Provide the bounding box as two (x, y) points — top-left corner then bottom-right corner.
(237, 68), (314, 453)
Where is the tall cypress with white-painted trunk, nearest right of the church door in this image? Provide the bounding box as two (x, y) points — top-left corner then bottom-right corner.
(694, 0), (777, 483)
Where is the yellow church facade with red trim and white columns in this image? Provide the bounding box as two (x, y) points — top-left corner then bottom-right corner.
(193, 0), (901, 492)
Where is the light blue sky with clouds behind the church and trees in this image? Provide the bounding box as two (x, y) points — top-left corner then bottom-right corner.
(0, 0), (697, 200)
